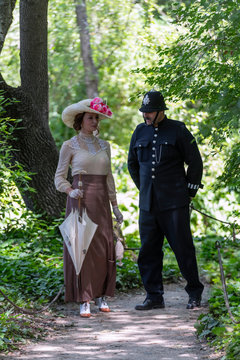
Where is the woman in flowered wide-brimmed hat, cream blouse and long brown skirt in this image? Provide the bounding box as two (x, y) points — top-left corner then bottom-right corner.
(55, 98), (123, 317)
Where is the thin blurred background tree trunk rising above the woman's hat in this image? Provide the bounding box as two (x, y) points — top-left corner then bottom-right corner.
(75, 0), (98, 99)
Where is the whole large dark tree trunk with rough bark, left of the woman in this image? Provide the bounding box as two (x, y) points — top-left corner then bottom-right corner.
(0, 0), (65, 216)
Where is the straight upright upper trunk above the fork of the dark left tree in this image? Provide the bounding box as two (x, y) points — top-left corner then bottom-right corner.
(20, 0), (48, 128)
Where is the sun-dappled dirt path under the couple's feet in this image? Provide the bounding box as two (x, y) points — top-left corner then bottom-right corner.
(0, 284), (221, 360)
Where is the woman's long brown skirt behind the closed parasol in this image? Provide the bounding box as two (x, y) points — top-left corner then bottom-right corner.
(63, 175), (116, 302)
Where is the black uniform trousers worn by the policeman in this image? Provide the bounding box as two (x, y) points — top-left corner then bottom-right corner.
(138, 202), (204, 301)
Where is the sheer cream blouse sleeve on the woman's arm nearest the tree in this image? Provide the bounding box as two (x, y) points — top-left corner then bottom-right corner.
(54, 142), (72, 192)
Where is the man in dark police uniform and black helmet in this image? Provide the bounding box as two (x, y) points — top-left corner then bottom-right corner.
(128, 90), (203, 310)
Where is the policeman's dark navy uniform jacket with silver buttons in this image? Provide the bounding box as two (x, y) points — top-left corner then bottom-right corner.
(128, 116), (203, 211)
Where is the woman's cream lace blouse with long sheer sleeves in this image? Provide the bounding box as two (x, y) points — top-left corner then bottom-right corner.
(55, 132), (116, 202)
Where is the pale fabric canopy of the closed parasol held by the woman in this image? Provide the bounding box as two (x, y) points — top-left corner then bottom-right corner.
(59, 209), (98, 275)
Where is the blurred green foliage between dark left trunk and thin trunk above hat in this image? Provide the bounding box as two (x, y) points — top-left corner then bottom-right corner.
(48, 1), (86, 146)
